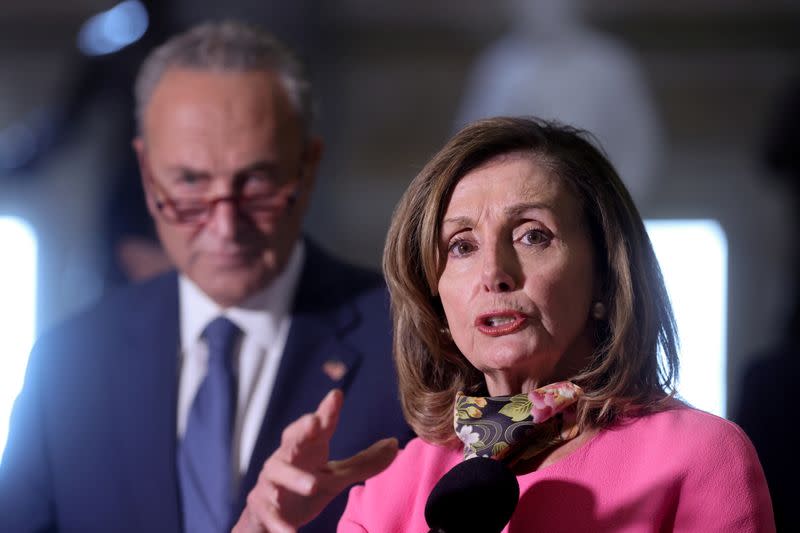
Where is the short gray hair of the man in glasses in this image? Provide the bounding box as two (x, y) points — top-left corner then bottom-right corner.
(134, 21), (314, 135)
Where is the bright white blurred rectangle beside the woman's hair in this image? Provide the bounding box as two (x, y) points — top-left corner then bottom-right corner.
(645, 220), (728, 417)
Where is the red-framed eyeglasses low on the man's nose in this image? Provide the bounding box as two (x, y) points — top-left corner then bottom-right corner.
(146, 173), (297, 225)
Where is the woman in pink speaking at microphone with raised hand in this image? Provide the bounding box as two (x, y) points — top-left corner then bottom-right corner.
(237, 118), (774, 532)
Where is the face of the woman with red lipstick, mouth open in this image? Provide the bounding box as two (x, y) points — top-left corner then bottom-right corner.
(439, 152), (595, 395)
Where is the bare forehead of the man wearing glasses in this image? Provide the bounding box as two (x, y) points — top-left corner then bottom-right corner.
(143, 69), (305, 170)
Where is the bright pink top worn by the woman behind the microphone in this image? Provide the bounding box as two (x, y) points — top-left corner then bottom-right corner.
(338, 407), (775, 533)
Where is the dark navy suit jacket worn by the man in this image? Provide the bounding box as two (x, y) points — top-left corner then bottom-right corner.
(0, 243), (410, 533)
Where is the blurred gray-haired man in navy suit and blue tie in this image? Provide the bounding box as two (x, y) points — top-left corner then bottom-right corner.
(0, 23), (410, 532)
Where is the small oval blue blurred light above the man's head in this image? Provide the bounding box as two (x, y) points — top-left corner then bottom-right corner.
(78, 0), (149, 56)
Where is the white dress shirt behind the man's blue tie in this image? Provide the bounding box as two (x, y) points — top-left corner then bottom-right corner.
(178, 241), (305, 483)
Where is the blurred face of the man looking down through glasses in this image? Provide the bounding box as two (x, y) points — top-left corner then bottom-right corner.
(134, 68), (321, 307)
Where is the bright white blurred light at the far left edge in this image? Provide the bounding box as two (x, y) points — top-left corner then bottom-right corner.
(0, 216), (36, 458)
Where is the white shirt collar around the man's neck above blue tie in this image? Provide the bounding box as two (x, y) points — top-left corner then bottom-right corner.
(178, 239), (305, 350)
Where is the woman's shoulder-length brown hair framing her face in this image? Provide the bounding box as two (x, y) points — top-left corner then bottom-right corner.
(383, 117), (678, 443)
